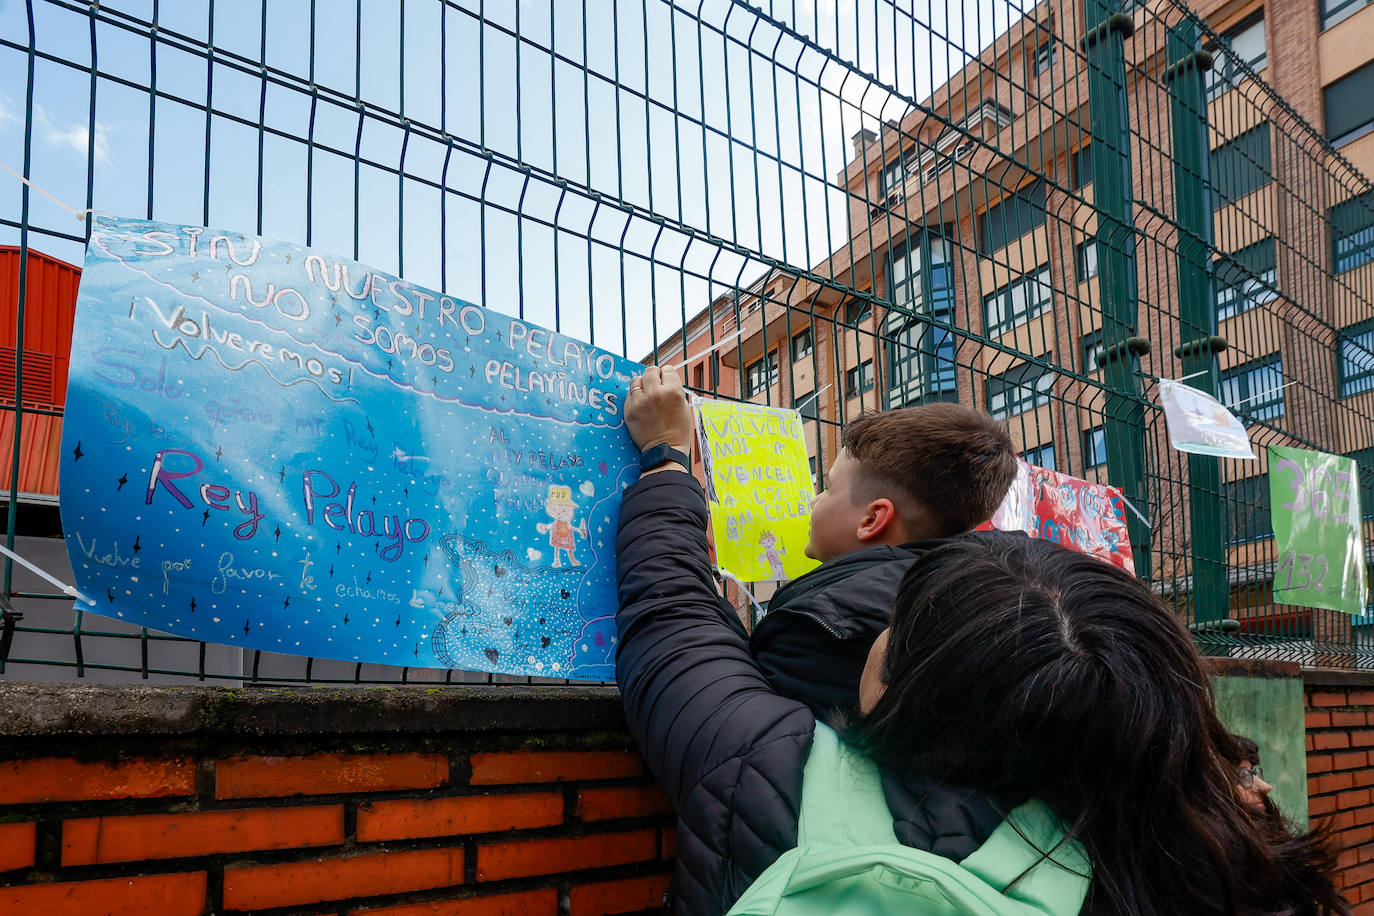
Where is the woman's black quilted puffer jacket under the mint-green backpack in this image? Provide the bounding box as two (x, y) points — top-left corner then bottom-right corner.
(616, 471), (1022, 916)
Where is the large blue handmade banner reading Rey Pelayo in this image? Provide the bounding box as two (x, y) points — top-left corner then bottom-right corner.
(60, 217), (640, 680)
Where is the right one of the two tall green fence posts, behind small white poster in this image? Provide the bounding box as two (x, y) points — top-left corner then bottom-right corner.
(1165, 18), (1230, 623)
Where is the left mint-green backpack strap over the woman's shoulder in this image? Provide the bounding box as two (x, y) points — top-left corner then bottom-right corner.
(797, 722), (897, 847)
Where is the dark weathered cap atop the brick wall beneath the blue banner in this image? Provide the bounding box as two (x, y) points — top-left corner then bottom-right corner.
(0, 681), (625, 739)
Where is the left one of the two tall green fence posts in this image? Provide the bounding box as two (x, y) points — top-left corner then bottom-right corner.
(1081, 0), (1150, 578)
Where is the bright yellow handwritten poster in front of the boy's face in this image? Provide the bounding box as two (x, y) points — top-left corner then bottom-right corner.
(697, 400), (819, 582)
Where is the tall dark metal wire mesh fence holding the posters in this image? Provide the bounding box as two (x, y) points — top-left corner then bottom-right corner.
(0, 0), (1374, 683)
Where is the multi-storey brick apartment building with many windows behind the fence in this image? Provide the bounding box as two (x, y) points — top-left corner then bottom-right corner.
(658, 0), (1374, 629)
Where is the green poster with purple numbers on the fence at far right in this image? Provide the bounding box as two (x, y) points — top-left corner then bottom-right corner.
(1268, 445), (1366, 614)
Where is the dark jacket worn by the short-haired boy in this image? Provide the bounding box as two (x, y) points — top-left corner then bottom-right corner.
(749, 540), (940, 718)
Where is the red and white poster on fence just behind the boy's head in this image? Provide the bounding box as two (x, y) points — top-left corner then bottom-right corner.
(978, 459), (1135, 573)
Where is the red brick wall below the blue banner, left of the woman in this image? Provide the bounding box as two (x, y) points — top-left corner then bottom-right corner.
(0, 692), (673, 916)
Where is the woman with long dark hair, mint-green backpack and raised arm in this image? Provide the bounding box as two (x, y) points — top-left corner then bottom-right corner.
(617, 369), (1349, 916)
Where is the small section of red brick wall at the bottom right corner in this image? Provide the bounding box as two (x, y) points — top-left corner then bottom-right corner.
(1303, 672), (1374, 915)
